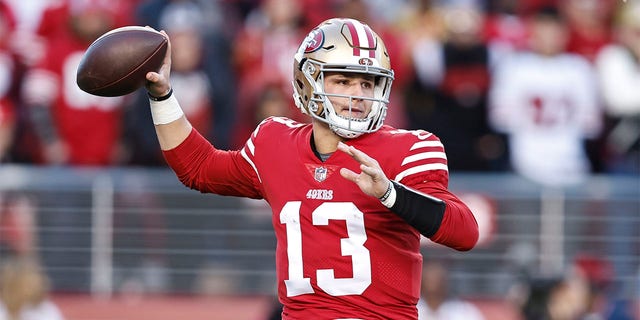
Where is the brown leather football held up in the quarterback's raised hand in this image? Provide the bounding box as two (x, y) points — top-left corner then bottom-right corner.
(76, 26), (168, 97)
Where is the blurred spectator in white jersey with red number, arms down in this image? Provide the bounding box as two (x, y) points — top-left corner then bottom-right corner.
(489, 7), (602, 186)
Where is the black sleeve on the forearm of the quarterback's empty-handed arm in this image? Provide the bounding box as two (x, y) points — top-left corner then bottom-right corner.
(390, 181), (446, 238)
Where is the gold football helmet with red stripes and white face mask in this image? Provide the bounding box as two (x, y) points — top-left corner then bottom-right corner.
(292, 18), (393, 138)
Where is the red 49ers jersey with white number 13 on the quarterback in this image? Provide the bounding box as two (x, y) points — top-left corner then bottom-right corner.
(165, 117), (477, 319)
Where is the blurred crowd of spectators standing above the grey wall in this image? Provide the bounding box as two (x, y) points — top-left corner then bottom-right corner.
(0, 0), (640, 178)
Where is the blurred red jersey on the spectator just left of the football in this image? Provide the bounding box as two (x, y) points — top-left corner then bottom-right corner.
(24, 30), (125, 165)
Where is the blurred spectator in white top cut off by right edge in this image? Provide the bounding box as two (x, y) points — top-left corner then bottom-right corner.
(595, 1), (640, 175)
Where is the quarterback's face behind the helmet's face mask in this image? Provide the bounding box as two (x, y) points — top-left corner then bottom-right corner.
(324, 72), (375, 119)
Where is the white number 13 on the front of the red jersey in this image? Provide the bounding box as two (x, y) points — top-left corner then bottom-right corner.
(280, 201), (371, 297)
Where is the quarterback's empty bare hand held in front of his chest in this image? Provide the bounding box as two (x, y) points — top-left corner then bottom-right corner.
(338, 142), (391, 198)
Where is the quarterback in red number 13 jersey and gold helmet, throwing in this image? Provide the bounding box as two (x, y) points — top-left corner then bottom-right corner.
(147, 19), (478, 319)
